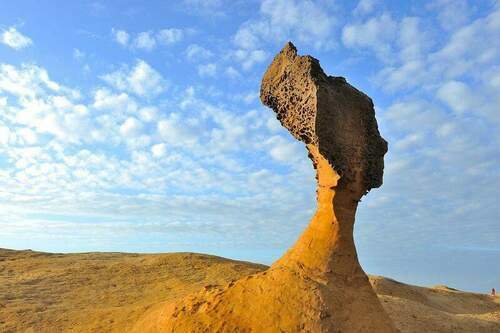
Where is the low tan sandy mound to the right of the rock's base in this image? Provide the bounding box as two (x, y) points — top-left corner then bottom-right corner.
(370, 276), (500, 333)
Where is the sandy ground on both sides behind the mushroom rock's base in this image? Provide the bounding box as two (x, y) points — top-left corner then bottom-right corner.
(0, 249), (500, 333)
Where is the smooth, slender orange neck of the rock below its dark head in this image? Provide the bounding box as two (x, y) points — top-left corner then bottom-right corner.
(273, 144), (363, 280)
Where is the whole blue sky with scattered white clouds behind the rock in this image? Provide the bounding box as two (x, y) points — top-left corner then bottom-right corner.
(0, 0), (500, 292)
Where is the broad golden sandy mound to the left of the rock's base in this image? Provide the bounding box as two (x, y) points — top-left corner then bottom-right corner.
(0, 250), (265, 333)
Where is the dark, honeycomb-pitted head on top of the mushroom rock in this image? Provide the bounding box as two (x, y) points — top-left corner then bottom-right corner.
(260, 43), (387, 195)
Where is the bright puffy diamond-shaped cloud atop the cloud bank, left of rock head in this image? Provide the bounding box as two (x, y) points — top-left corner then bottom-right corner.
(100, 59), (166, 97)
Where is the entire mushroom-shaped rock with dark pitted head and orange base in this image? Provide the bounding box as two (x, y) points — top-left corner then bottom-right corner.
(136, 43), (397, 333)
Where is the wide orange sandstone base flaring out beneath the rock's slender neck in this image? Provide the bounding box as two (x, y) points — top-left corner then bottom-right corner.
(137, 267), (396, 333)
